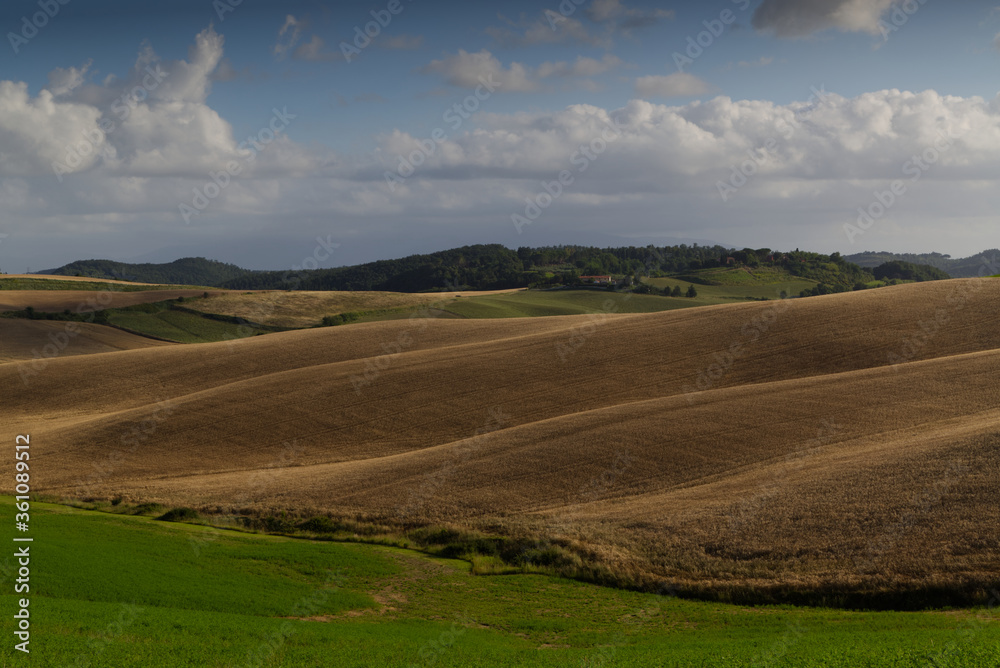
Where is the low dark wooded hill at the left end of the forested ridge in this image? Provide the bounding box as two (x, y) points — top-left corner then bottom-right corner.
(45, 257), (253, 286)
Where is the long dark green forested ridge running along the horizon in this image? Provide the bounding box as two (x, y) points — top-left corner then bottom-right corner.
(37, 244), (949, 296)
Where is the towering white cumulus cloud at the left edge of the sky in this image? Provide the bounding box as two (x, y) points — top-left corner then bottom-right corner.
(0, 28), (322, 189)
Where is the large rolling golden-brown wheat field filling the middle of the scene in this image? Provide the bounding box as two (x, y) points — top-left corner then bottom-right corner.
(0, 280), (1000, 600)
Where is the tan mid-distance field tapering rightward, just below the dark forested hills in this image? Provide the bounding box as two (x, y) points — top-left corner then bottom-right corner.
(191, 290), (532, 328)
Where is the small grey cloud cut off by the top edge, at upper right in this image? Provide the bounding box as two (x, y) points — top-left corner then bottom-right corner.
(753, 0), (894, 37)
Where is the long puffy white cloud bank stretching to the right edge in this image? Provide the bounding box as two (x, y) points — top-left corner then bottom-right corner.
(373, 90), (1000, 200)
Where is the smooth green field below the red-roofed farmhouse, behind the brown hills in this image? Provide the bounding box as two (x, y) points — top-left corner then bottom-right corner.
(440, 290), (698, 318)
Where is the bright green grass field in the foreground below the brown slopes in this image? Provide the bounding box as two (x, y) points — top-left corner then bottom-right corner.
(0, 497), (1000, 668)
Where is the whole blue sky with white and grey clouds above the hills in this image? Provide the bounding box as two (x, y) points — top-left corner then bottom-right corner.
(0, 0), (1000, 273)
